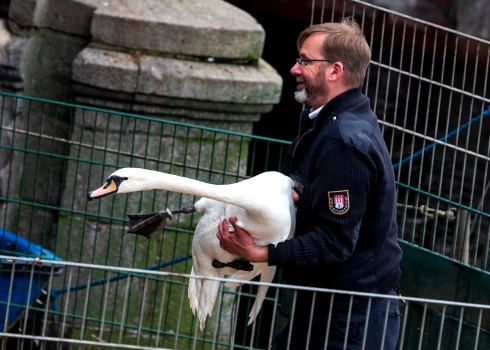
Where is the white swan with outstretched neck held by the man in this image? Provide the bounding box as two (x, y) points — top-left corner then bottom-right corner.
(88, 168), (296, 331)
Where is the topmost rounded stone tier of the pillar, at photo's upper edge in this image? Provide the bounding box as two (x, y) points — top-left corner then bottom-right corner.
(91, 0), (265, 60)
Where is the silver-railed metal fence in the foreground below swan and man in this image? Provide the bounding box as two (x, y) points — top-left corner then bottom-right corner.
(0, 255), (490, 349)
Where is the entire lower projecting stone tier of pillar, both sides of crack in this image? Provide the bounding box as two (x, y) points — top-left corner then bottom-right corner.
(73, 48), (282, 105)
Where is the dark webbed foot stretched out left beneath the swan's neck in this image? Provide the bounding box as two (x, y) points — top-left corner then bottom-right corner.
(128, 205), (196, 239)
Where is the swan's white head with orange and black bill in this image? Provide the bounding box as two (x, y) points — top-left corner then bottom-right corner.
(87, 168), (152, 201)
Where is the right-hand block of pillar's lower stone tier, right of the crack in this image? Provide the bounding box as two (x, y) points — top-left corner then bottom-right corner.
(137, 56), (282, 104)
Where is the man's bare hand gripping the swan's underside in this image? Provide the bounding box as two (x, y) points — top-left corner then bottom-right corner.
(216, 216), (269, 262)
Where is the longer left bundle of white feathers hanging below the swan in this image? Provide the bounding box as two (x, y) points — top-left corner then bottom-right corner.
(188, 267), (220, 332)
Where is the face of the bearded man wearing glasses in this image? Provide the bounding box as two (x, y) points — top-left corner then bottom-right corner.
(291, 33), (328, 109)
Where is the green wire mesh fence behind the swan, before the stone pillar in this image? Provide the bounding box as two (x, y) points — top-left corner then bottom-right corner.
(0, 94), (289, 349)
